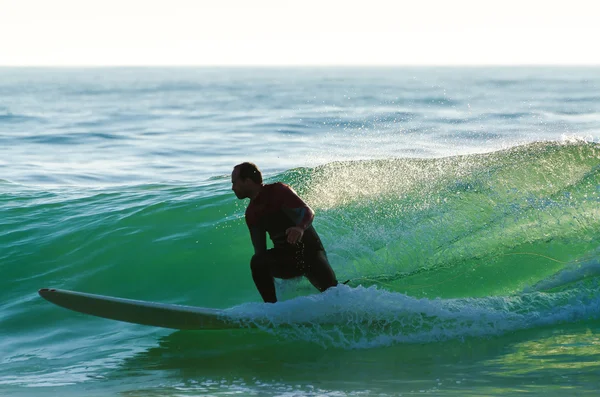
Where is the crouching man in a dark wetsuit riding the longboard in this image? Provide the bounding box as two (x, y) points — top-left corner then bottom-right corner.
(231, 163), (338, 303)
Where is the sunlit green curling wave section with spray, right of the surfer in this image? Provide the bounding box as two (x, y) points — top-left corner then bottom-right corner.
(282, 143), (600, 297)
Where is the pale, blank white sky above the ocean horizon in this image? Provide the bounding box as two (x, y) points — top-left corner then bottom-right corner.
(0, 0), (600, 66)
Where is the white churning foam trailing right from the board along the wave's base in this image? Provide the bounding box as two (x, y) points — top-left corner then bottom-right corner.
(227, 285), (600, 348)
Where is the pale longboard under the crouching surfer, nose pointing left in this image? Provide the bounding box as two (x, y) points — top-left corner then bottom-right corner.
(38, 288), (249, 329)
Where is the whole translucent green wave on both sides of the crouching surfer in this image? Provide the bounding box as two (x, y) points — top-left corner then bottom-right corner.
(0, 142), (600, 347)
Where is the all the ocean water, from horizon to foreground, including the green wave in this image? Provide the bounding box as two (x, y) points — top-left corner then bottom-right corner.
(0, 67), (600, 397)
